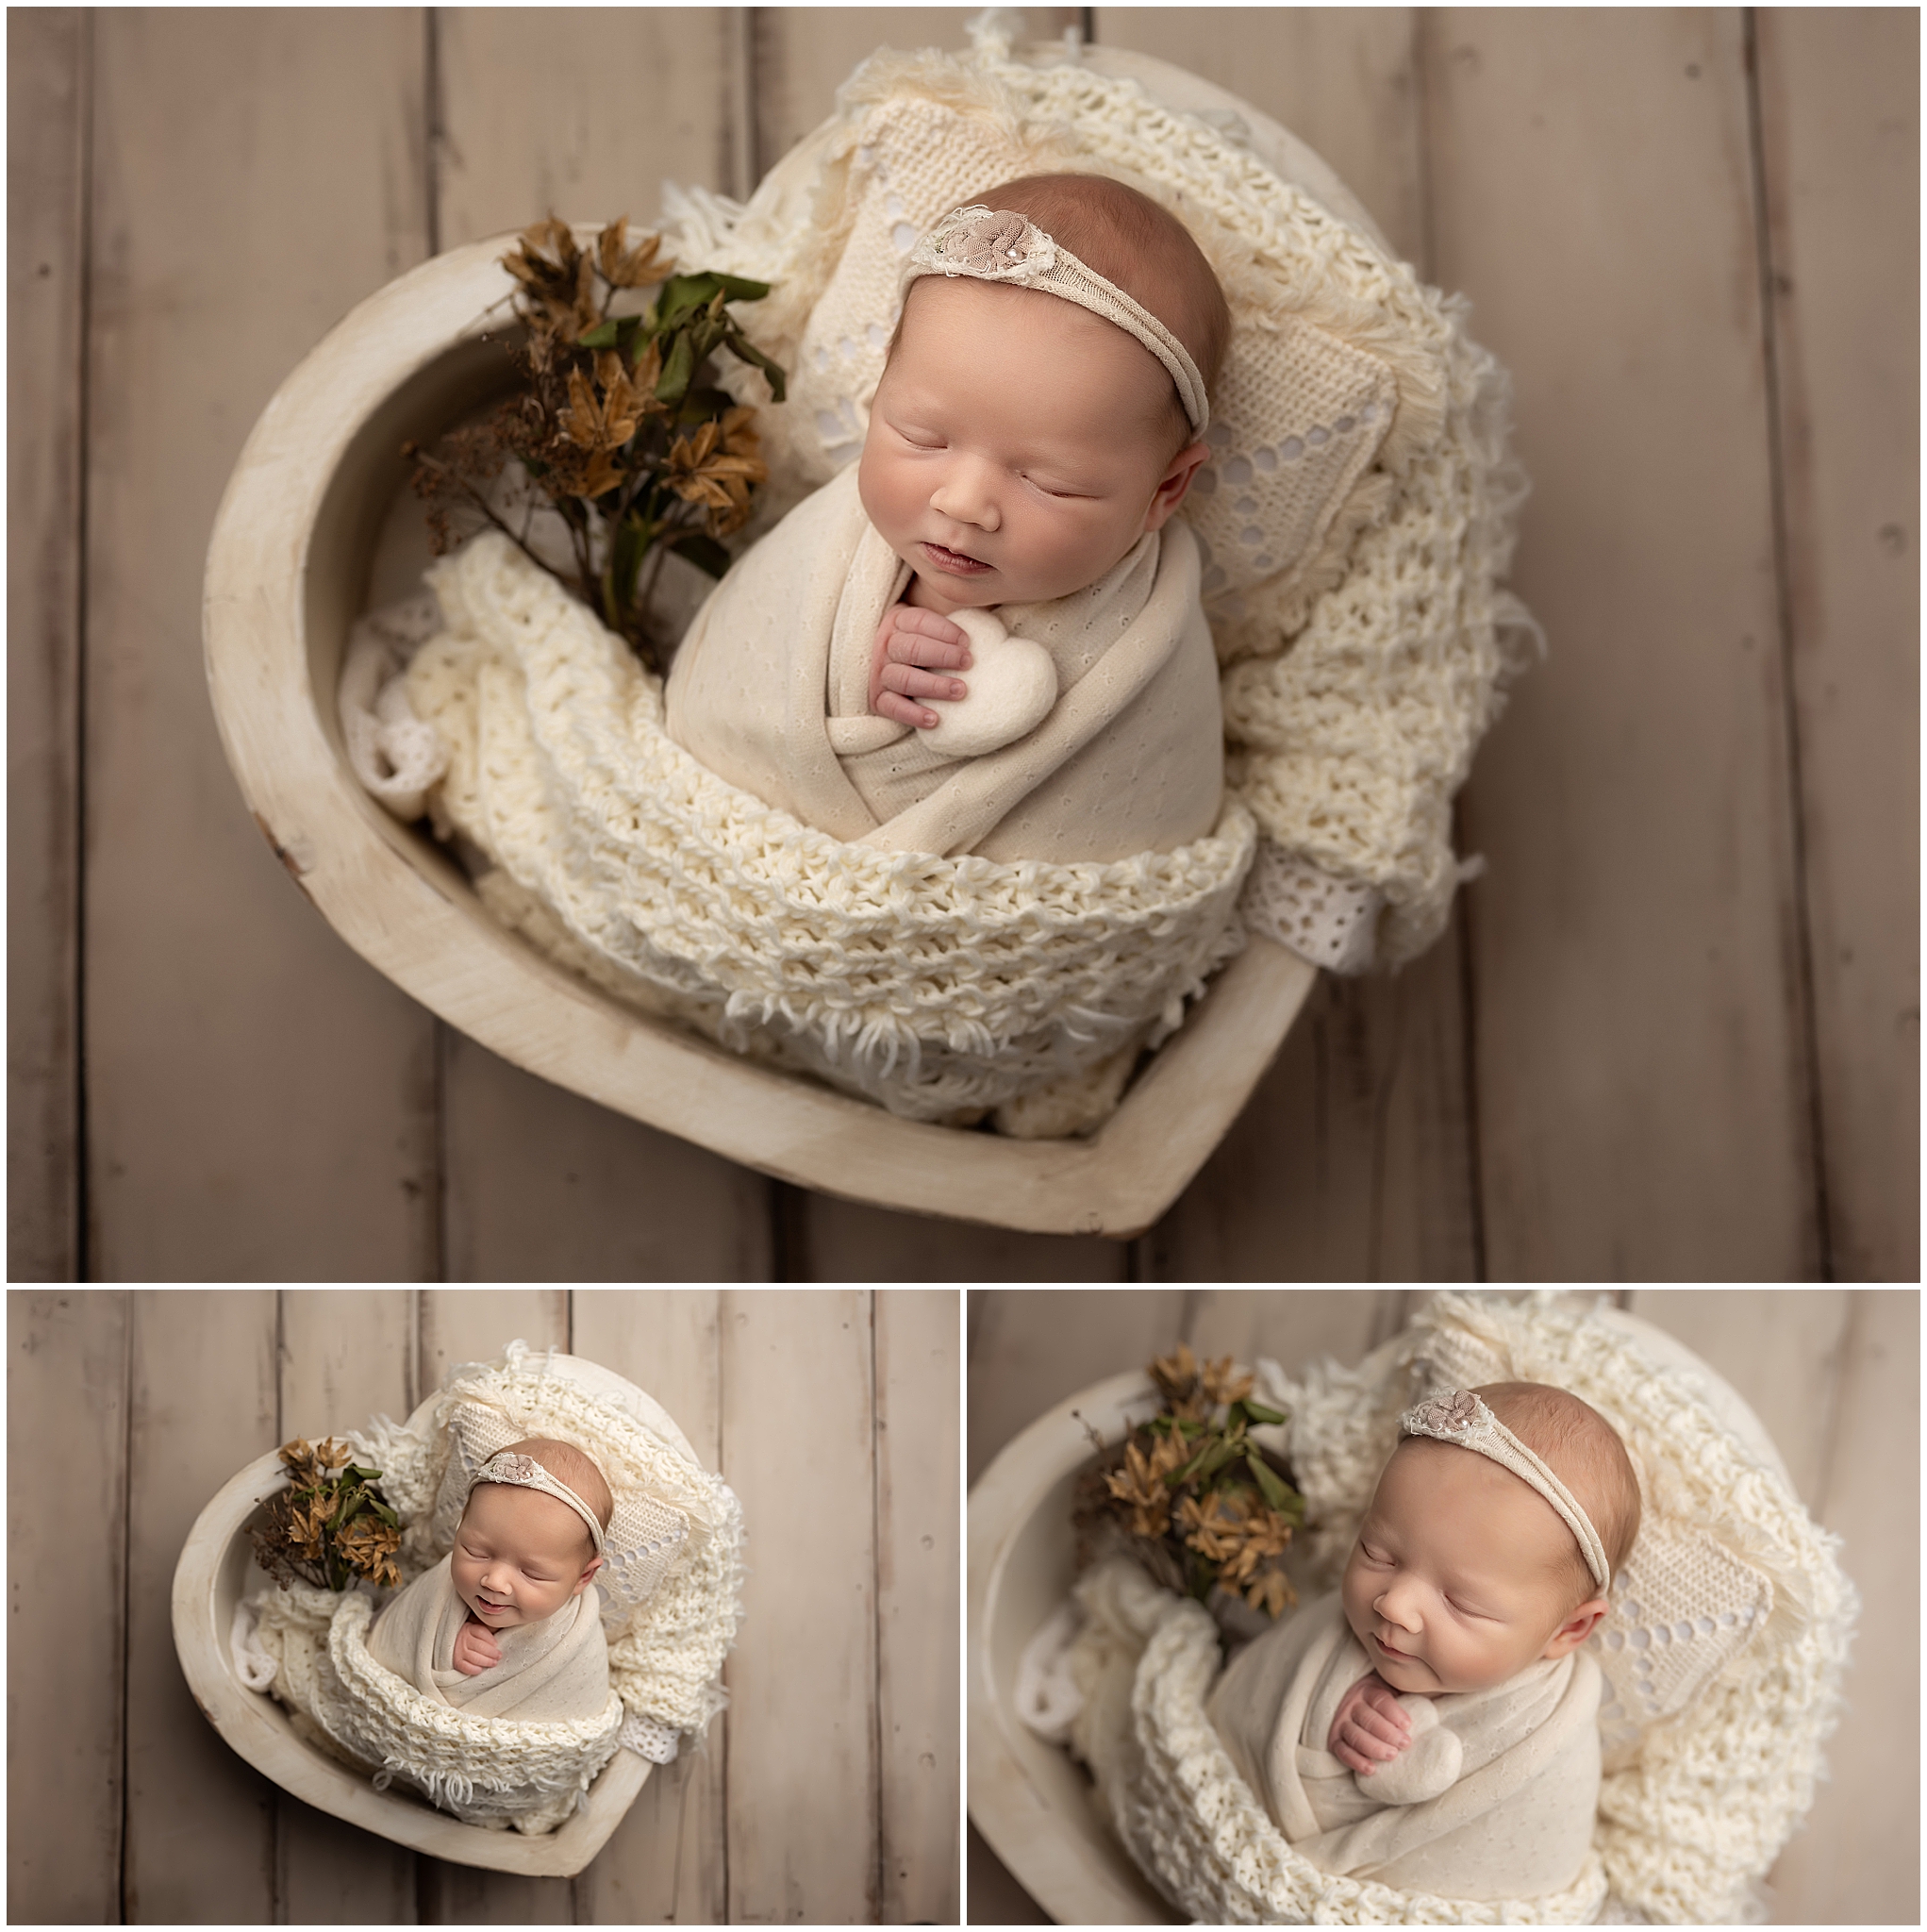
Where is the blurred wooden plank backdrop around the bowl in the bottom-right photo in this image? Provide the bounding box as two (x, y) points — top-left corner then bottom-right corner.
(968, 1289), (1921, 1924)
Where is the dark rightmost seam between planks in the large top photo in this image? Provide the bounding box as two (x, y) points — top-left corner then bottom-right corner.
(1741, 8), (1835, 1281)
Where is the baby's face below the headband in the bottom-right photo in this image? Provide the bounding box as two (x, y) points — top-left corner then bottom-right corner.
(1342, 1441), (1603, 1696)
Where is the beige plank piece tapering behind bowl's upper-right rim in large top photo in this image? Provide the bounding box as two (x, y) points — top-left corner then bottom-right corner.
(1091, 6), (1425, 263)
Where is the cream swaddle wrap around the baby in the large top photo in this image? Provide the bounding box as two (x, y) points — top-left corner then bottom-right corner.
(668, 466), (1224, 866)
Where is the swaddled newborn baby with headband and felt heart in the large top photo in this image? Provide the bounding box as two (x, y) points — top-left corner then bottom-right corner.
(668, 175), (1230, 863)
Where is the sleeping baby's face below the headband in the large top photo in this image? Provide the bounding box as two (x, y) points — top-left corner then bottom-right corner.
(857, 276), (1204, 614)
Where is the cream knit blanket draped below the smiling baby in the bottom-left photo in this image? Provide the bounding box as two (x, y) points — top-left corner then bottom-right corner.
(257, 1584), (623, 1836)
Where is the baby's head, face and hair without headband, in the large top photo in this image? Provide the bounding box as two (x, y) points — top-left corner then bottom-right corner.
(857, 174), (1230, 612)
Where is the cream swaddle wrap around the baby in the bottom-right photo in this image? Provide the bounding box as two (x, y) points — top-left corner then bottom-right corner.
(1208, 1592), (1599, 1899)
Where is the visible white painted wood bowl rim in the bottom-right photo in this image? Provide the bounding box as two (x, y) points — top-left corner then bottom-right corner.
(968, 1310), (1792, 1924)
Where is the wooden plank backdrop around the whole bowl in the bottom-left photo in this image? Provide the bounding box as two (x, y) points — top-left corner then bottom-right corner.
(8, 1287), (959, 1924)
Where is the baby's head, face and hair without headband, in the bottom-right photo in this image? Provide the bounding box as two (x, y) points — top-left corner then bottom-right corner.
(1342, 1381), (1639, 1696)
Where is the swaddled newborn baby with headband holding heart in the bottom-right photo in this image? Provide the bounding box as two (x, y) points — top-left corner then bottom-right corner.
(1211, 1381), (1639, 1899)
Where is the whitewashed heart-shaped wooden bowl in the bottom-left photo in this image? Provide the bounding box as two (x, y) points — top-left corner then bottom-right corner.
(172, 1355), (697, 1878)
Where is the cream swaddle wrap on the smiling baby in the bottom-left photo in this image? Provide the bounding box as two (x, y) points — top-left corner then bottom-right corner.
(369, 1557), (610, 1722)
